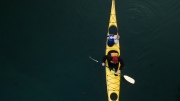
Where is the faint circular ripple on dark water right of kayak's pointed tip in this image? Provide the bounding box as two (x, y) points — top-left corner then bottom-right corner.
(124, 4), (157, 34)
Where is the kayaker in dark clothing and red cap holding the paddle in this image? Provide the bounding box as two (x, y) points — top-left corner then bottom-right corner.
(102, 50), (124, 74)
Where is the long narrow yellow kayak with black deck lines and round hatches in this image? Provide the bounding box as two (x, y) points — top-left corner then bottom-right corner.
(106, 0), (120, 101)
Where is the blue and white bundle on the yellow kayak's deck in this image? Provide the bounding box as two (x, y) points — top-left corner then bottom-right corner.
(107, 34), (120, 47)
